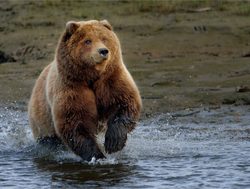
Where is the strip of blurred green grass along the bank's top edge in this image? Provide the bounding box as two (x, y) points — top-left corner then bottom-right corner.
(9, 0), (250, 16)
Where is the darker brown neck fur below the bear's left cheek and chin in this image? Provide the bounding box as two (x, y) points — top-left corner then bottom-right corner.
(56, 43), (99, 85)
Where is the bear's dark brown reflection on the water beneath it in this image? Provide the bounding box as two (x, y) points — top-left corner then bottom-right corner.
(34, 158), (135, 187)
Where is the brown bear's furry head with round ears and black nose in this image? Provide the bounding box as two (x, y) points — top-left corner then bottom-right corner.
(57, 20), (121, 83)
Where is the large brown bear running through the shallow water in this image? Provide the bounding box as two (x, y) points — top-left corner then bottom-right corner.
(28, 20), (142, 161)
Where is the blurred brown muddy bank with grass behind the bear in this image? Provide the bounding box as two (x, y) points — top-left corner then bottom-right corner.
(0, 0), (250, 116)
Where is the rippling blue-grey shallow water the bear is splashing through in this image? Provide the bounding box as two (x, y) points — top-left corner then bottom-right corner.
(0, 106), (250, 189)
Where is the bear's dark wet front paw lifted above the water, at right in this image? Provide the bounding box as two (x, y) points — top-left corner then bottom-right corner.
(104, 119), (128, 154)
